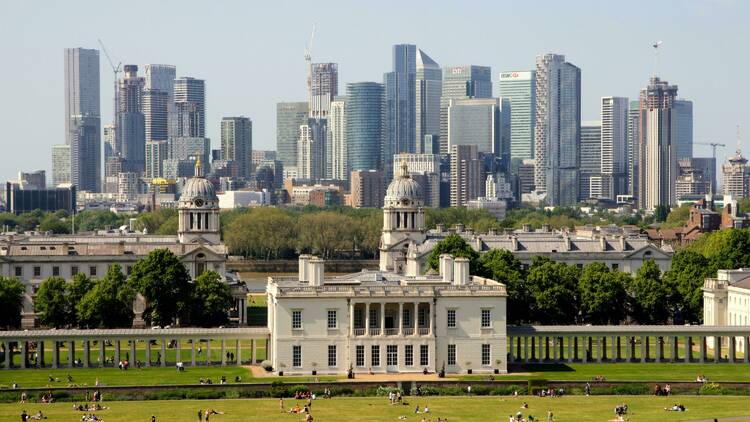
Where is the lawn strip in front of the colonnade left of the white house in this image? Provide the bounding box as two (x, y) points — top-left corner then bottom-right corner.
(0, 366), (338, 390)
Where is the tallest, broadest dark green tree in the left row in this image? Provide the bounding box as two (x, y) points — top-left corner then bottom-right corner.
(128, 249), (192, 326)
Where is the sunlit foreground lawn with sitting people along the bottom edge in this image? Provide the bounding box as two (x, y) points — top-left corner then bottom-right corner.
(0, 396), (750, 422)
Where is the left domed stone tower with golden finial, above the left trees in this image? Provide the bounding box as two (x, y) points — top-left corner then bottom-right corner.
(177, 159), (221, 244)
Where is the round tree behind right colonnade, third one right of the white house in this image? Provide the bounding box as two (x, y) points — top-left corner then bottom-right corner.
(578, 262), (630, 325)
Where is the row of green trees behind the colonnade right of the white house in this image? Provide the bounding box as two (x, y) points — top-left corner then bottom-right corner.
(428, 235), (707, 325)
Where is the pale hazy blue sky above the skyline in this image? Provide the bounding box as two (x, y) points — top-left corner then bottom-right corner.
(0, 0), (750, 181)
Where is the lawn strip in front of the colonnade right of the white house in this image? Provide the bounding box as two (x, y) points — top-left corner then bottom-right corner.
(458, 362), (750, 382)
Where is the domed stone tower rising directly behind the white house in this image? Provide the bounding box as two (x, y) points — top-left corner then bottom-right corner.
(380, 162), (426, 273)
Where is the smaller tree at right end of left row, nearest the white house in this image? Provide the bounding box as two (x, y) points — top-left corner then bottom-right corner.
(190, 271), (232, 327)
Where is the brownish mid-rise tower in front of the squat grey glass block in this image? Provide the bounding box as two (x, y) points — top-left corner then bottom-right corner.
(450, 145), (485, 207)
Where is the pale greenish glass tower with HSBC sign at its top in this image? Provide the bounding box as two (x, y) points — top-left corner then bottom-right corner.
(500, 70), (536, 160)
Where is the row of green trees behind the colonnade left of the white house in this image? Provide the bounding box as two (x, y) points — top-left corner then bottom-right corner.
(0, 249), (232, 328)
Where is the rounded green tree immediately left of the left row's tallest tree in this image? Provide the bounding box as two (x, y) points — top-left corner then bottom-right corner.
(76, 264), (135, 328)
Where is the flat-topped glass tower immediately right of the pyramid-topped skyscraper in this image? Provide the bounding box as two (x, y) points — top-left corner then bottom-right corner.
(440, 65), (492, 154)
